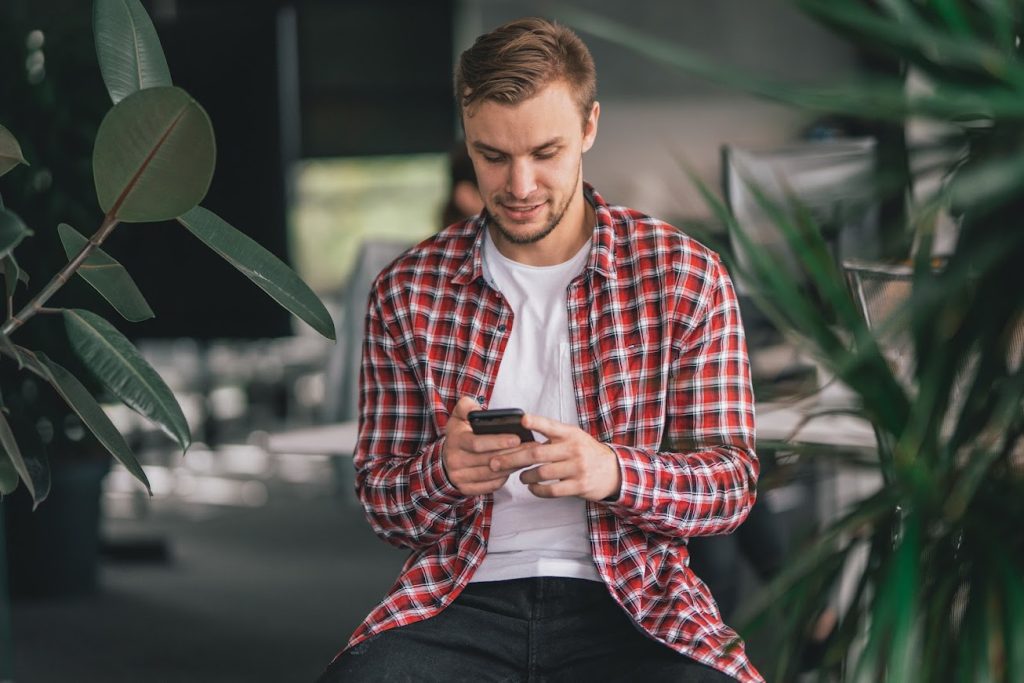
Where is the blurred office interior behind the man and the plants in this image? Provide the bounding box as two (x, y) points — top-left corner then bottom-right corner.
(0, 0), (974, 683)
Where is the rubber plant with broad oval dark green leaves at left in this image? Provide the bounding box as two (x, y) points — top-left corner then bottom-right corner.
(0, 0), (335, 598)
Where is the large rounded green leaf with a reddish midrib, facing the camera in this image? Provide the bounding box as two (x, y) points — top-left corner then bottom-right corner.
(92, 87), (216, 223)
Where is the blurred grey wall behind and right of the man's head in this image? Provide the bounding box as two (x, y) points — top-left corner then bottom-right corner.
(455, 0), (857, 221)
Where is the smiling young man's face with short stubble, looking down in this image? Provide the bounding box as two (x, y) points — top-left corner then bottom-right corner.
(464, 81), (599, 245)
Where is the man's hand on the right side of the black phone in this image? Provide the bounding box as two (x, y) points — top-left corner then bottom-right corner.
(490, 415), (622, 501)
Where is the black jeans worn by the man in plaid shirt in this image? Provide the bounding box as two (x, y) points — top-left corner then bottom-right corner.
(317, 578), (733, 683)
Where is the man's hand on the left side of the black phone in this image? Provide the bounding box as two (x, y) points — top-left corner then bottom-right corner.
(441, 396), (537, 496)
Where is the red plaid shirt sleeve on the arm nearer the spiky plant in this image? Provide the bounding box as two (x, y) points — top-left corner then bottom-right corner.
(609, 260), (758, 538)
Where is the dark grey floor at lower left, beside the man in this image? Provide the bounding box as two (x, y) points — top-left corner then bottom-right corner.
(11, 475), (403, 683)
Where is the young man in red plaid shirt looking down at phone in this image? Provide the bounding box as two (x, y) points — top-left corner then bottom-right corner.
(321, 15), (761, 681)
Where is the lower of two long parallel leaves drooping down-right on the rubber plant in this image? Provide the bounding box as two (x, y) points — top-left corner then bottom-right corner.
(18, 348), (153, 496)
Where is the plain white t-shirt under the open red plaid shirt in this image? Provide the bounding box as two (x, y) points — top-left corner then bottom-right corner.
(472, 228), (600, 582)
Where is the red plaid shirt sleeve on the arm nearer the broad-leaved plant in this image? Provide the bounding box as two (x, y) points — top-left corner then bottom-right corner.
(354, 278), (465, 549)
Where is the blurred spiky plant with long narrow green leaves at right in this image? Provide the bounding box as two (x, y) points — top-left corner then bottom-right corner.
(565, 0), (1024, 682)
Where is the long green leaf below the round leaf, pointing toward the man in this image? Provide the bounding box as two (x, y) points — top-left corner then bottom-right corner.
(178, 207), (335, 340)
